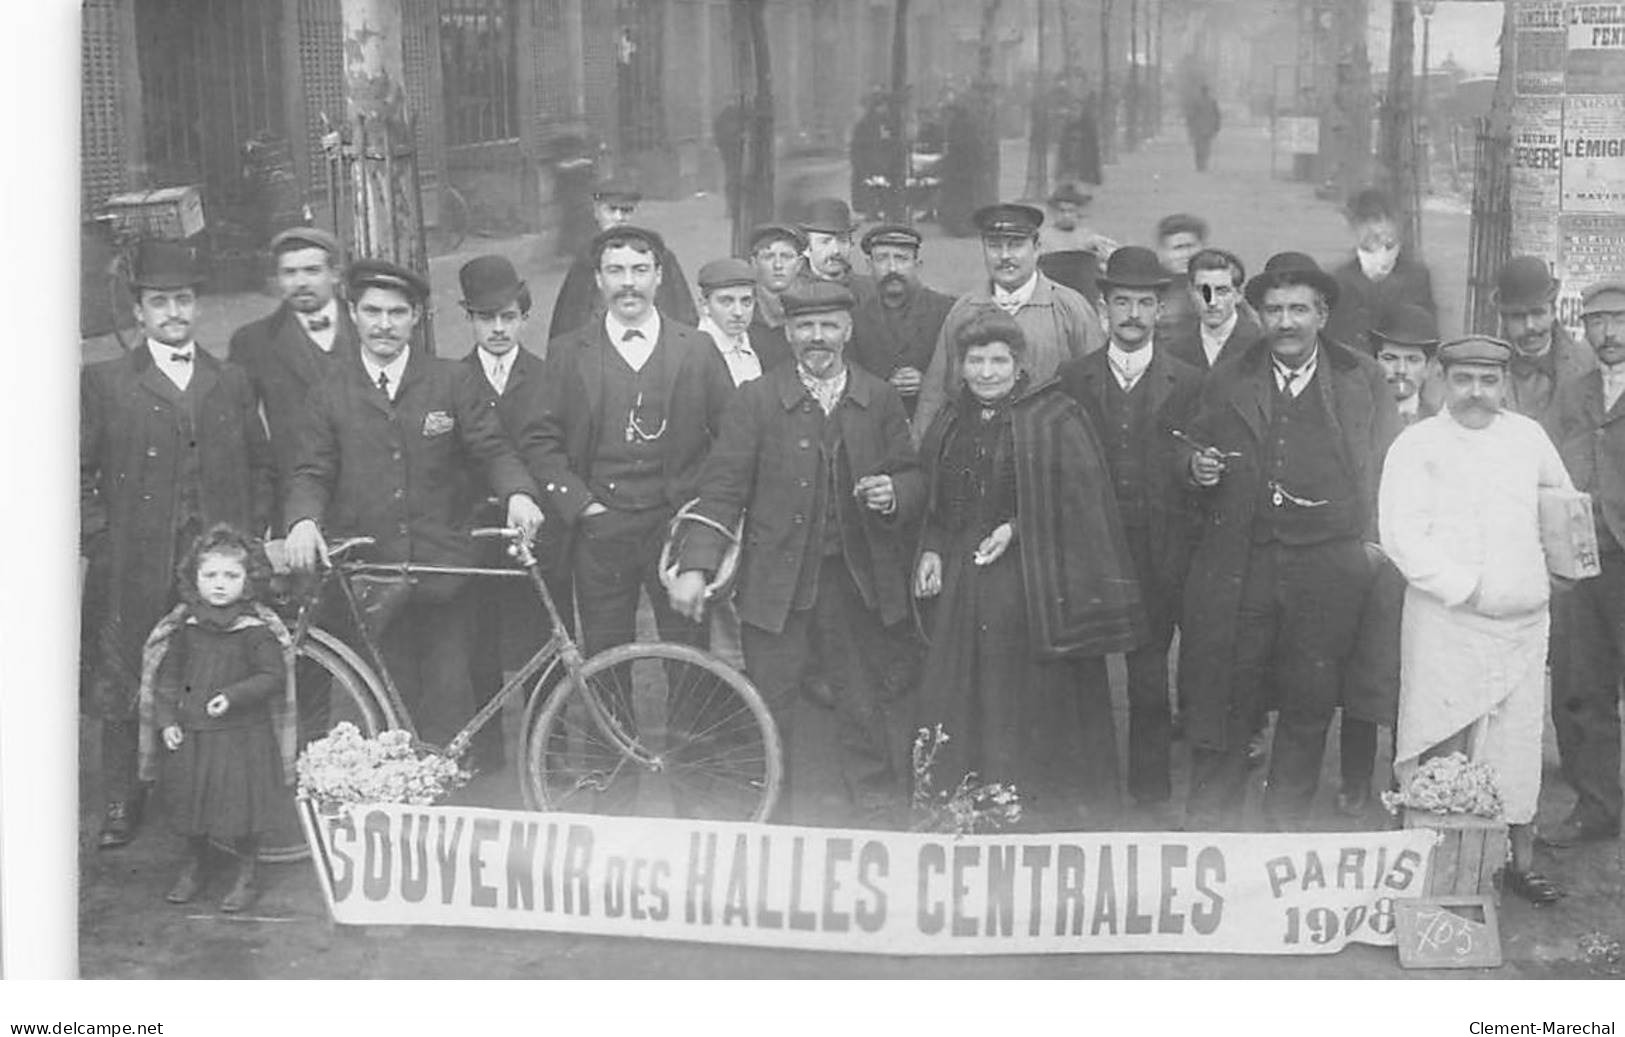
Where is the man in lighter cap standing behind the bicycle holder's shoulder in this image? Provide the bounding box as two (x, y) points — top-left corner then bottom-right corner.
(229, 228), (358, 520)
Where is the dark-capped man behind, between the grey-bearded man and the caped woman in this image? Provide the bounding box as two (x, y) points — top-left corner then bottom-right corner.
(852, 223), (954, 414)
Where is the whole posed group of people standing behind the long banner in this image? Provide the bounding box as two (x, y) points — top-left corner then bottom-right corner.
(81, 174), (1625, 910)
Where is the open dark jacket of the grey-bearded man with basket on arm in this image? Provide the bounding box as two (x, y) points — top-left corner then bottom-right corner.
(681, 364), (925, 634)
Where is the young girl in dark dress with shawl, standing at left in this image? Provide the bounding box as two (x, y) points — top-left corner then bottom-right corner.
(141, 525), (294, 912)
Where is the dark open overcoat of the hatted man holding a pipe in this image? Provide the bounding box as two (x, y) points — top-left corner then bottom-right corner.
(1175, 336), (1399, 749)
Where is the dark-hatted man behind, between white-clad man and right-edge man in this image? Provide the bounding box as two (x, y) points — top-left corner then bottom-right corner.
(1490, 255), (1597, 439)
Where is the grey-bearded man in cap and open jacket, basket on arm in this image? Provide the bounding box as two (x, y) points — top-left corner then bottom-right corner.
(671, 283), (925, 824)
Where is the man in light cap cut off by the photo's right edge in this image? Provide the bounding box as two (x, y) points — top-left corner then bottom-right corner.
(1540, 281), (1625, 847)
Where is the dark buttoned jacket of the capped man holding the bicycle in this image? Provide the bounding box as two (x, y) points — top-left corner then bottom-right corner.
(284, 346), (540, 588)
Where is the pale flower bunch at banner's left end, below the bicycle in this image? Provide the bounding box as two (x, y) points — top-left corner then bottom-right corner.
(296, 723), (468, 813)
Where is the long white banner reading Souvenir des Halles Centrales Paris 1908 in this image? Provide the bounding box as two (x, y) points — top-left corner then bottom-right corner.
(301, 803), (1437, 954)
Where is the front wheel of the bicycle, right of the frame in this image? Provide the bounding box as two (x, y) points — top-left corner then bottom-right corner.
(523, 644), (783, 821)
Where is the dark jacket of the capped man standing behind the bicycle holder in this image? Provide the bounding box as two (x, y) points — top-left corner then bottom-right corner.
(229, 302), (359, 520)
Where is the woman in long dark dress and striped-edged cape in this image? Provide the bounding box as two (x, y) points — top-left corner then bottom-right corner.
(915, 314), (1146, 831)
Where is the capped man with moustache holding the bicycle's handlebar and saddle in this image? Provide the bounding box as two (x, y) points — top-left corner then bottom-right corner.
(283, 258), (541, 744)
